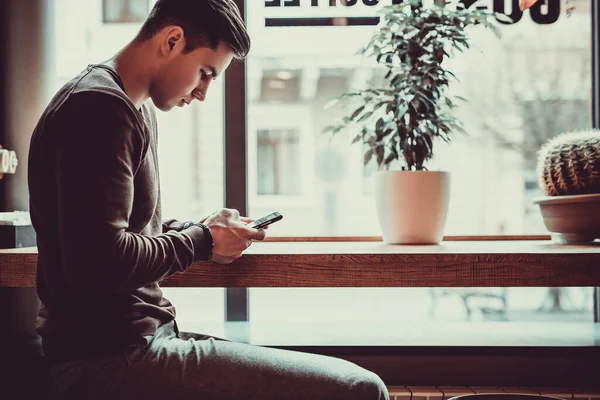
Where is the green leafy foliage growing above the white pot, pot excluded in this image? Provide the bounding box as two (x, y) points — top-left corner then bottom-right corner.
(324, 0), (512, 171)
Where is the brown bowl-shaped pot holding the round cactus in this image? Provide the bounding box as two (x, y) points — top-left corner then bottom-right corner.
(533, 194), (600, 244)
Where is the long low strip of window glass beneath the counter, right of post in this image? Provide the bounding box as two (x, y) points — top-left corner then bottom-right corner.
(250, 287), (594, 323)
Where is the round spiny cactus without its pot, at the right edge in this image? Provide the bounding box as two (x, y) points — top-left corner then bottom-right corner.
(538, 130), (600, 196)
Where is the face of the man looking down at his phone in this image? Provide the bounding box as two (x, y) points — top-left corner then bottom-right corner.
(149, 42), (233, 111)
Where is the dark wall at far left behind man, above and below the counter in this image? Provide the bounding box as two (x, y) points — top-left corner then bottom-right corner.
(0, 0), (54, 354)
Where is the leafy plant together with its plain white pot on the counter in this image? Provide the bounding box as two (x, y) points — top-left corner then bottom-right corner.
(324, 0), (512, 244)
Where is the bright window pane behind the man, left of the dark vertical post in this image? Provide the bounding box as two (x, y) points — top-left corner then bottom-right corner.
(54, 0), (224, 322)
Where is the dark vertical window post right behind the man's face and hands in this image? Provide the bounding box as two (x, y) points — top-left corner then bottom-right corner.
(225, 0), (249, 321)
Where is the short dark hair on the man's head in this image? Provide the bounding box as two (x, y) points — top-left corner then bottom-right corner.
(137, 0), (250, 59)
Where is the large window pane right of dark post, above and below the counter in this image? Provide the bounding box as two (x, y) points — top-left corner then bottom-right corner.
(247, 0), (593, 322)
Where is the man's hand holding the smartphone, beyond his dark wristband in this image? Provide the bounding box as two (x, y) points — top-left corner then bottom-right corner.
(202, 208), (266, 264)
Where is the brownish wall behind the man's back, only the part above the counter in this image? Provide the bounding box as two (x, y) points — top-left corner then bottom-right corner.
(0, 0), (55, 211)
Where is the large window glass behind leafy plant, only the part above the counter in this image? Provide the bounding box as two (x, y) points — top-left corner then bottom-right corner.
(247, 0), (591, 236)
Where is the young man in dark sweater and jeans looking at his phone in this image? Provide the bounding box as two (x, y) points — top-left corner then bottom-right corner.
(29, 0), (388, 399)
